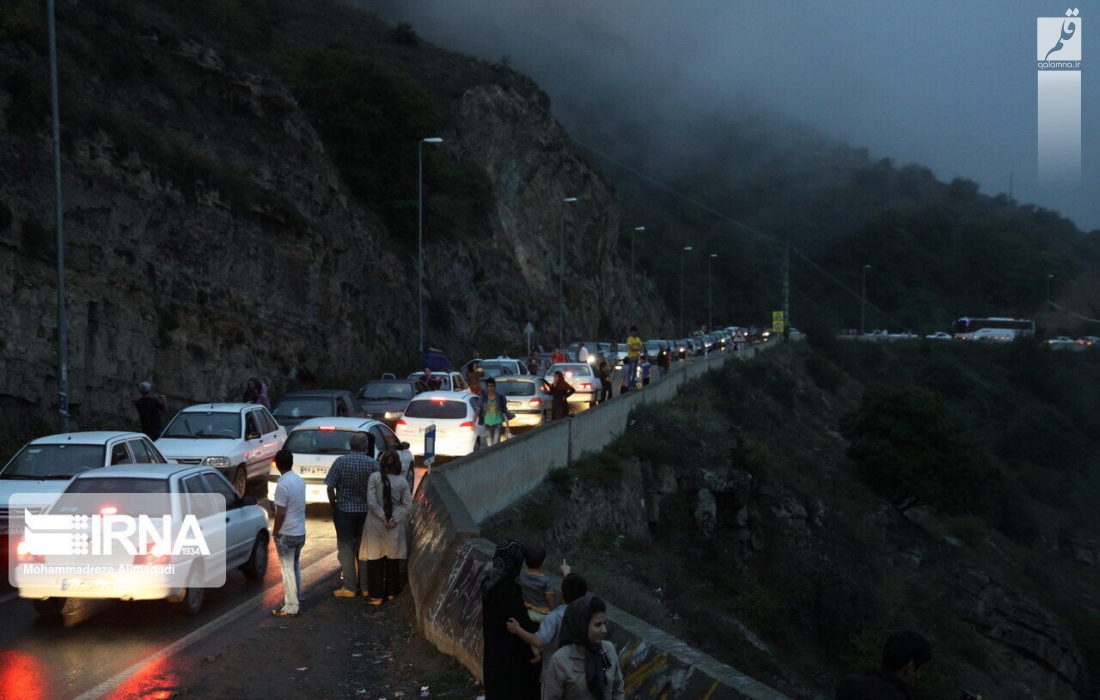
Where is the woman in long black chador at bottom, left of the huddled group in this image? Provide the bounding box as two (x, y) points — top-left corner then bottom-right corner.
(482, 539), (539, 700)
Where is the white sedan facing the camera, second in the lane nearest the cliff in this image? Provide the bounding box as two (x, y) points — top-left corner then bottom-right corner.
(155, 404), (286, 494)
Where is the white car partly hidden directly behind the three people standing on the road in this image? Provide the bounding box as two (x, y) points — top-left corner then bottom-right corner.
(267, 418), (413, 503)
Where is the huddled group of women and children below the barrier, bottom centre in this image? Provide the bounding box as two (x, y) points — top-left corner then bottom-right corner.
(482, 539), (625, 700)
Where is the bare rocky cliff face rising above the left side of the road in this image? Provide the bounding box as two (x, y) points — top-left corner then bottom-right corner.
(0, 13), (660, 437)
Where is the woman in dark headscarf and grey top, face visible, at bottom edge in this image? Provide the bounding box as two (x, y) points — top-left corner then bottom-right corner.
(542, 595), (624, 700)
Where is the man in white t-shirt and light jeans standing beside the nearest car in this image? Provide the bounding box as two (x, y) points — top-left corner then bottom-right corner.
(272, 450), (306, 617)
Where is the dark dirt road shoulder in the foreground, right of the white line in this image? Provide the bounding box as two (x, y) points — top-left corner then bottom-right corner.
(137, 575), (481, 700)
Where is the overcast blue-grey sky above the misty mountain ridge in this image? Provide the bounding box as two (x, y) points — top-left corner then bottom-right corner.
(363, 0), (1100, 230)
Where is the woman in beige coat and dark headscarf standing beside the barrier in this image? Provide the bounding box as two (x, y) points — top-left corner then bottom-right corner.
(359, 450), (413, 605)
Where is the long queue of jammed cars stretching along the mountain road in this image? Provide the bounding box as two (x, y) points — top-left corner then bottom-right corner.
(0, 329), (756, 615)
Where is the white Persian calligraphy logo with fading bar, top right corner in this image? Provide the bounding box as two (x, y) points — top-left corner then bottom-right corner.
(1035, 8), (1082, 186)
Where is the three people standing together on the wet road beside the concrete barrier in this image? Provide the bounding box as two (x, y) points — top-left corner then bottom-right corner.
(272, 433), (413, 617)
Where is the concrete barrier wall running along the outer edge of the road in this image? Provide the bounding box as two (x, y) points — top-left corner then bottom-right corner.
(408, 353), (787, 700)
